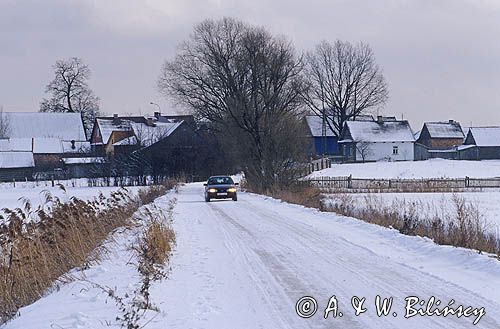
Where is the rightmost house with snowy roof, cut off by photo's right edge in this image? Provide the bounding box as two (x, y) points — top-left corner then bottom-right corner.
(458, 127), (500, 160)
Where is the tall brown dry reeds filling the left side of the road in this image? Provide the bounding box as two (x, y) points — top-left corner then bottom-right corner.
(0, 186), (172, 323)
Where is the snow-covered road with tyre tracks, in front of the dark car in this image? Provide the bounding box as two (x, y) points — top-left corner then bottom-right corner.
(160, 184), (500, 329)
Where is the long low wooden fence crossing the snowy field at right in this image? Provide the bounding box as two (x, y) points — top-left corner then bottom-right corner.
(307, 176), (500, 192)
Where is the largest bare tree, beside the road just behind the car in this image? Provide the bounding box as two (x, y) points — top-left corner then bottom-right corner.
(159, 18), (303, 190)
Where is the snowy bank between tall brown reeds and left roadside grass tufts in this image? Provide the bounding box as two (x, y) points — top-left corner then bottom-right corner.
(0, 192), (173, 329)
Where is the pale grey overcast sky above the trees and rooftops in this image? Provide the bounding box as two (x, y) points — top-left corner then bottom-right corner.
(0, 0), (500, 130)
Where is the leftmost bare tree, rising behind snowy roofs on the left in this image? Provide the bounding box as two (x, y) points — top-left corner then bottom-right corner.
(40, 57), (99, 136)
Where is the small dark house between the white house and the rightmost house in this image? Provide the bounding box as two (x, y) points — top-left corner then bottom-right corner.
(415, 120), (464, 160)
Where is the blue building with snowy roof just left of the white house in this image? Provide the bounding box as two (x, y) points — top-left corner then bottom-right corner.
(305, 115), (342, 157)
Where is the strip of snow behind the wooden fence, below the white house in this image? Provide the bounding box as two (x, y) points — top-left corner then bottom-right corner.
(310, 159), (500, 178)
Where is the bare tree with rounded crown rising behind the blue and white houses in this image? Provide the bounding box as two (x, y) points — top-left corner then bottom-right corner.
(304, 40), (388, 136)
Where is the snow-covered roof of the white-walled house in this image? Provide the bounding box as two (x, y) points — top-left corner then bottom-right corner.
(342, 120), (415, 142)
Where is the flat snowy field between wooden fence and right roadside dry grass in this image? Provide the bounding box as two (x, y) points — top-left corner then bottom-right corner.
(320, 192), (500, 236)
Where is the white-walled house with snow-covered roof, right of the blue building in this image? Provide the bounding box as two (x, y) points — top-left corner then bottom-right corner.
(339, 116), (415, 161)
